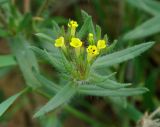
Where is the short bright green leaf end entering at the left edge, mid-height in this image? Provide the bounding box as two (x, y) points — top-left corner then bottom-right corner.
(0, 55), (17, 67)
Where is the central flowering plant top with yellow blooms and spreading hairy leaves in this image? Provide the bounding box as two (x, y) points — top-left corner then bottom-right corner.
(32, 11), (154, 117)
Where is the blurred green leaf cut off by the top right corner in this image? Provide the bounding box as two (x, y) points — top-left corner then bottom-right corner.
(127, 0), (160, 15)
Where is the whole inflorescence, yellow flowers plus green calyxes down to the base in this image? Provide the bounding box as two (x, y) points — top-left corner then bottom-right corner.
(54, 20), (108, 80)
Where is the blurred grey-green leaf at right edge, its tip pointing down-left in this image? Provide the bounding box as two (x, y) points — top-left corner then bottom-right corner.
(123, 16), (160, 40)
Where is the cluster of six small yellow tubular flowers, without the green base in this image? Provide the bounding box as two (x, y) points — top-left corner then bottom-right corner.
(54, 20), (107, 63)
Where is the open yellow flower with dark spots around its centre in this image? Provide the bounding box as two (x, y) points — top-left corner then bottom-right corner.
(87, 45), (99, 56)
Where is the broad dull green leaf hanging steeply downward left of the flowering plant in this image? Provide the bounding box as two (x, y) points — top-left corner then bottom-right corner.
(8, 34), (40, 88)
